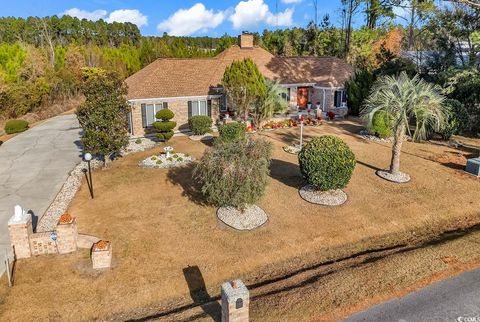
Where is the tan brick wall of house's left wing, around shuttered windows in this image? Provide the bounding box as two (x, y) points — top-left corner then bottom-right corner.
(132, 98), (220, 137)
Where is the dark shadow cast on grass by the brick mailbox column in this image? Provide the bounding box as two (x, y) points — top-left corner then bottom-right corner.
(183, 265), (222, 321)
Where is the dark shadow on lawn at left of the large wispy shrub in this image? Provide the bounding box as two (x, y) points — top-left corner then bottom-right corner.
(167, 162), (207, 206)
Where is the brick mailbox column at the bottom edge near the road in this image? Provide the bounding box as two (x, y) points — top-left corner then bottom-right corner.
(221, 280), (250, 322)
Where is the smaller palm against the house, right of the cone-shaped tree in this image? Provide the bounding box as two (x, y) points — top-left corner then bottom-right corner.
(252, 80), (288, 127)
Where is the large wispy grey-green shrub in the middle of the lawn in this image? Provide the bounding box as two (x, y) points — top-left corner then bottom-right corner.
(194, 139), (272, 209)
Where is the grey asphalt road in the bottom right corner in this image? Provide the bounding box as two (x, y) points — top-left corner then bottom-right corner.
(345, 269), (480, 322)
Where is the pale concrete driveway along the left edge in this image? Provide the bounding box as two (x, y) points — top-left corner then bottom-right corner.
(0, 115), (81, 262)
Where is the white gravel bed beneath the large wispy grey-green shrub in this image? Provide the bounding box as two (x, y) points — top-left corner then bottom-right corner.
(217, 205), (268, 230)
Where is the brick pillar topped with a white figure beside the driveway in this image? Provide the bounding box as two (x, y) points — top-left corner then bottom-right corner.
(8, 205), (33, 259)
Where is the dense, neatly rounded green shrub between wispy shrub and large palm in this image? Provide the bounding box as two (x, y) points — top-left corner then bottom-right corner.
(298, 135), (356, 191)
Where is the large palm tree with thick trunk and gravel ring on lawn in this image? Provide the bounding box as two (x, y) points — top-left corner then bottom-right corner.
(361, 72), (447, 182)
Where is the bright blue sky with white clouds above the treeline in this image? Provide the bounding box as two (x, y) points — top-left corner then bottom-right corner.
(0, 0), (352, 36)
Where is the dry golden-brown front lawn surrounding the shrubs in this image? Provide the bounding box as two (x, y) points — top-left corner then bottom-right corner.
(0, 121), (480, 321)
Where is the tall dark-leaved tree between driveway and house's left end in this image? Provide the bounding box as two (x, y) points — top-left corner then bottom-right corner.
(76, 69), (130, 166)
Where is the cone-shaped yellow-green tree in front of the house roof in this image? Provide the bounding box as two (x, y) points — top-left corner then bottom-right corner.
(222, 58), (267, 119)
